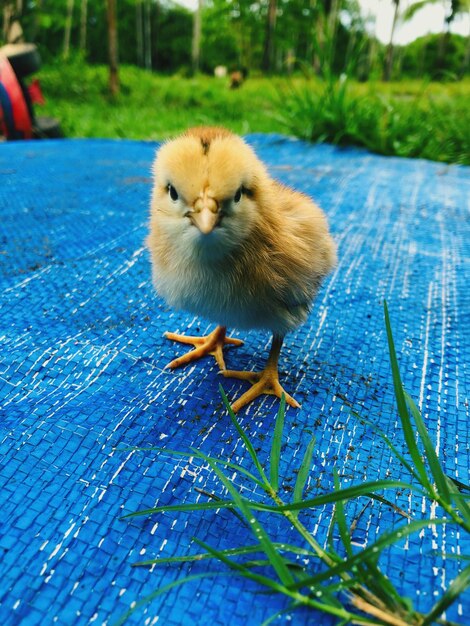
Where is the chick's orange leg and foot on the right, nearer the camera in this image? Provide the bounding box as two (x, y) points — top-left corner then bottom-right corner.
(222, 335), (300, 413)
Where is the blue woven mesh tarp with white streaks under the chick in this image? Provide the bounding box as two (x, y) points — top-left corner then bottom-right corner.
(0, 135), (470, 626)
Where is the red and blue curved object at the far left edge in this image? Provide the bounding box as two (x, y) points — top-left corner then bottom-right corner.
(0, 57), (33, 139)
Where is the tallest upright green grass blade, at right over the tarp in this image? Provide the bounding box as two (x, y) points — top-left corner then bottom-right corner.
(384, 301), (433, 494)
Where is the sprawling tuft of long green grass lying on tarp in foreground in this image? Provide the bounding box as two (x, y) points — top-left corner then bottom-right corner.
(117, 303), (470, 626)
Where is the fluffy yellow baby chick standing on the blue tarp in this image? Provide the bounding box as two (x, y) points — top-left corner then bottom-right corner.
(148, 127), (336, 411)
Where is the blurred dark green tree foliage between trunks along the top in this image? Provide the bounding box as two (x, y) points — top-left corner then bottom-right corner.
(13, 0), (469, 80)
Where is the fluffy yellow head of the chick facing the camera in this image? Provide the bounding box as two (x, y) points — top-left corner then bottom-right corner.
(152, 128), (267, 259)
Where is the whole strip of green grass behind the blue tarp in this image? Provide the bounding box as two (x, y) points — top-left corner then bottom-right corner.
(41, 60), (470, 165)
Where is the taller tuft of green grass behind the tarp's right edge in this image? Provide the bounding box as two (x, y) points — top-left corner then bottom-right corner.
(278, 76), (470, 165)
